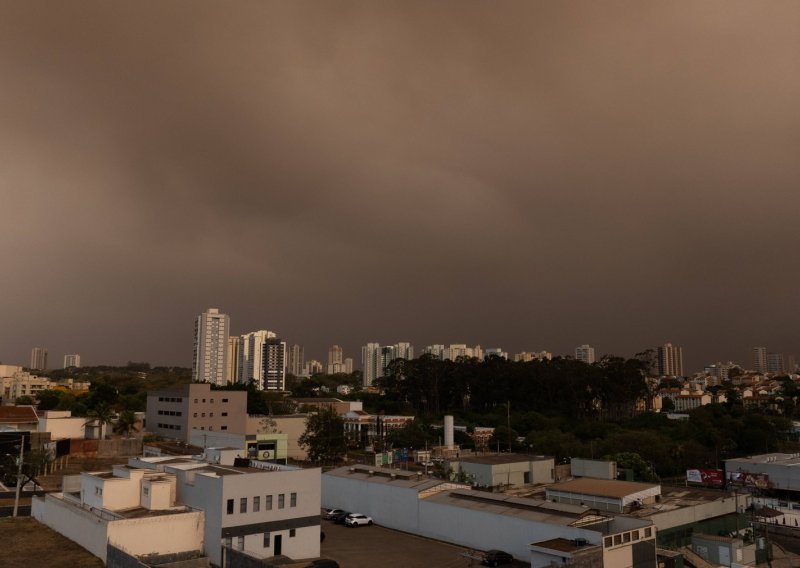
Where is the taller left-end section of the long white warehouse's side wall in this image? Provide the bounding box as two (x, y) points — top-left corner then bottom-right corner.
(322, 475), (422, 533)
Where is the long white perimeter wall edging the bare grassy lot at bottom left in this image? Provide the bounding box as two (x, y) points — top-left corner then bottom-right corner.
(31, 495), (108, 562)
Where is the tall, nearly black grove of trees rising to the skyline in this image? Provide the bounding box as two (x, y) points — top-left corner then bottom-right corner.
(375, 355), (649, 420)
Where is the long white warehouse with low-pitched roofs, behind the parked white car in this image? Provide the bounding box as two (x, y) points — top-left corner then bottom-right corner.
(322, 466), (656, 568)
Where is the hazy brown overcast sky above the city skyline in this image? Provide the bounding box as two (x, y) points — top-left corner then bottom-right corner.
(0, 0), (800, 370)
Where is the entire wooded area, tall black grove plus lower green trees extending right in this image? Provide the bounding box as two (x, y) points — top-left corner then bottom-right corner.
(372, 356), (798, 479)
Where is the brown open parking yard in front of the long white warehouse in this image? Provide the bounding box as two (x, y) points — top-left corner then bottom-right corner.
(322, 520), (530, 568)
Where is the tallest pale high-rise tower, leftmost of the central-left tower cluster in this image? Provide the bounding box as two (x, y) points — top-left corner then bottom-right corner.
(192, 308), (230, 385)
